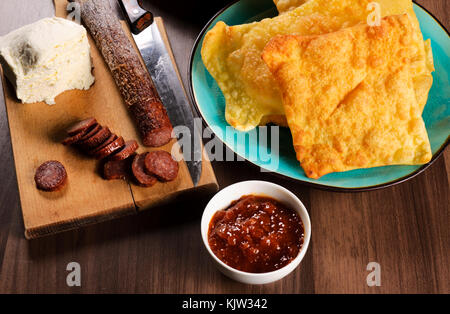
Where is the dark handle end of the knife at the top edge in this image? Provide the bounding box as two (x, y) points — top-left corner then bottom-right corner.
(119, 0), (153, 35)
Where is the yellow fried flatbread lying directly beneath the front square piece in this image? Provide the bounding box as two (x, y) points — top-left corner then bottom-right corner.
(202, 0), (432, 131)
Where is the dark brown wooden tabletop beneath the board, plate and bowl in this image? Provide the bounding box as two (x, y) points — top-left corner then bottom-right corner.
(0, 0), (450, 293)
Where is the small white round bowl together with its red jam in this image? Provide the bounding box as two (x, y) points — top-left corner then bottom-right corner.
(201, 181), (311, 284)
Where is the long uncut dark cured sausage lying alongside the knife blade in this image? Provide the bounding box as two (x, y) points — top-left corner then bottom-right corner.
(71, 0), (172, 147)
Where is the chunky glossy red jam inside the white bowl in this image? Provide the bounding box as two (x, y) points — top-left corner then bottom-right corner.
(208, 195), (304, 273)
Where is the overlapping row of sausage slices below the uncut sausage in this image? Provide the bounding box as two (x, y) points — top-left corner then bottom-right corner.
(62, 118), (178, 187)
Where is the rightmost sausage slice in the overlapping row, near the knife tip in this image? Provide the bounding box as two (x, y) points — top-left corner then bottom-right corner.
(145, 151), (178, 181)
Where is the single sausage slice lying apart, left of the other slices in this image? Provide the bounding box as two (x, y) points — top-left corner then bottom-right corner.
(34, 160), (67, 192)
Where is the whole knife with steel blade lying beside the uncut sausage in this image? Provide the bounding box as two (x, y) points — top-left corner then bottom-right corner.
(119, 0), (202, 186)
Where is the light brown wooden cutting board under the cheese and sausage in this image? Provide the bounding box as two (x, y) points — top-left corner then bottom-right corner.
(1, 0), (218, 239)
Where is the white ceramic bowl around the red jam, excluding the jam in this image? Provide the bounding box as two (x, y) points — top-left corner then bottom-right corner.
(201, 181), (311, 285)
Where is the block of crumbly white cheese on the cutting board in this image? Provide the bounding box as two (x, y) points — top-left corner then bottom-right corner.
(0, 17), (94, 104)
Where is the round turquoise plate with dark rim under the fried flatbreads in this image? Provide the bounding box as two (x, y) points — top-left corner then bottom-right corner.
(189, 0), (450, 191)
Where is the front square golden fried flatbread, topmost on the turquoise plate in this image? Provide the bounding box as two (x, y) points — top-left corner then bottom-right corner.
(263, 14), (431, 179)
